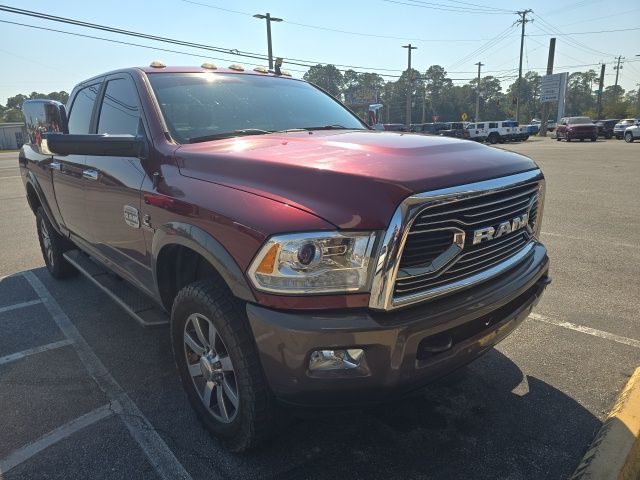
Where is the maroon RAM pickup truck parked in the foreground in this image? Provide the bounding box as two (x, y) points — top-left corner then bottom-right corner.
(19, 64), (550, 451)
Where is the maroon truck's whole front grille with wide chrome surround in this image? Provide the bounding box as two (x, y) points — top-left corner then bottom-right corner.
(369, 169), (544, 311)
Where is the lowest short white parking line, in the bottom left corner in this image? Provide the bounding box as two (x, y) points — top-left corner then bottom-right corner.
(0, 403), (119, 472)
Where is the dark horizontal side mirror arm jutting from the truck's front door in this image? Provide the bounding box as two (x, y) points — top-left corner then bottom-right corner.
(47, 133), (147, 158)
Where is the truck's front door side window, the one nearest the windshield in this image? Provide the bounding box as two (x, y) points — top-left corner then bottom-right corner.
(98, 78), (140, 135)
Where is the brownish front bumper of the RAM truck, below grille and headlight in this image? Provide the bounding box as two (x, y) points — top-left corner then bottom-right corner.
(247, 244), (549, 406)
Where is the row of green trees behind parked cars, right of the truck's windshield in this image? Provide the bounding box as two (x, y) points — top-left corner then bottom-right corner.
(303, 64), (640, 124)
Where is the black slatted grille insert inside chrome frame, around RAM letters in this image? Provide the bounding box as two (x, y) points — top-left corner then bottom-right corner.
(394, 183), (538, 297)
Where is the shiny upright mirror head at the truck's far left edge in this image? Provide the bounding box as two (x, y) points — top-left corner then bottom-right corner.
(22, 99), (69, 155)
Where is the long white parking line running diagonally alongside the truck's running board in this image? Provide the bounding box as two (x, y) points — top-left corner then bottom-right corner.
(24, 271), (191, 480)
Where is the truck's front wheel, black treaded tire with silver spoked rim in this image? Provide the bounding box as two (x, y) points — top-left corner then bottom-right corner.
(171, 278), (283, 452)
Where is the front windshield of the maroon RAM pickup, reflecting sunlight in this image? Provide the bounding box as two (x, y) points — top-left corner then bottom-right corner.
(148, 73), (366, 143)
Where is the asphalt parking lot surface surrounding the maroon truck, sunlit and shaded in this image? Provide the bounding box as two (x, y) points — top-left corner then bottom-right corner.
(0, 138), (640, 480)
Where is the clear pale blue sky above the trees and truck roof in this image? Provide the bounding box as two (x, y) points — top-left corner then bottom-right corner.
(0, 0), (640, 104)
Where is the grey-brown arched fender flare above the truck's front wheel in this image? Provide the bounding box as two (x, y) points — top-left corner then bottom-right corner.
(151, 222), (256, 302)
